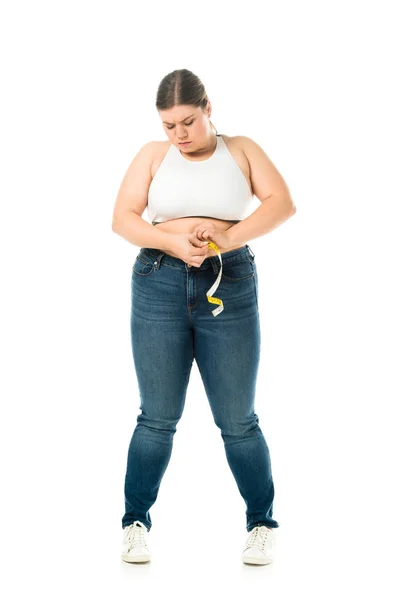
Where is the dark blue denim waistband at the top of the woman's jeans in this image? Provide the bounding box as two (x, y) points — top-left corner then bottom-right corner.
(139, 244), (255, 273)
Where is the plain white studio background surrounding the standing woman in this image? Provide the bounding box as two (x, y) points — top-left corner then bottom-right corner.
(0, 0), (400, 600)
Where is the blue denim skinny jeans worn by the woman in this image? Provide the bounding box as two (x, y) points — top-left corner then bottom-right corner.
(122, 244), (279, 531)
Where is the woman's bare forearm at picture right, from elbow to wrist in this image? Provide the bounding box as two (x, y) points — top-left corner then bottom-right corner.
(227, 194), (296, 246)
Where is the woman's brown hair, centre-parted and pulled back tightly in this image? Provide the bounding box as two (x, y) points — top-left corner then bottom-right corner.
(156, 69), (217, 133)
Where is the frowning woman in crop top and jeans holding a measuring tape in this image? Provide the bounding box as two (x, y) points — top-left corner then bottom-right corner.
(113, 69), (295, 564)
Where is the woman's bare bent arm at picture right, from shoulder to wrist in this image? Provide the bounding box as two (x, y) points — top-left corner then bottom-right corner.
(227, 136), (296, 246)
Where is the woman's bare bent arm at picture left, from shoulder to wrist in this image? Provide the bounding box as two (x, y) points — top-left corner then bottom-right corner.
(112, 142), (170, 251)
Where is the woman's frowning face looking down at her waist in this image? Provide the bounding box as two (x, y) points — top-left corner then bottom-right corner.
(158, 104), (212, 152)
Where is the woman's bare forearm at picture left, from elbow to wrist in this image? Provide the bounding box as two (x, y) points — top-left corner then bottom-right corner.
(112, 212), (170, 252)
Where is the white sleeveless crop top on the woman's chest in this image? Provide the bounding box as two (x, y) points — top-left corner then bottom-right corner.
(147, 134), (253, 225)
